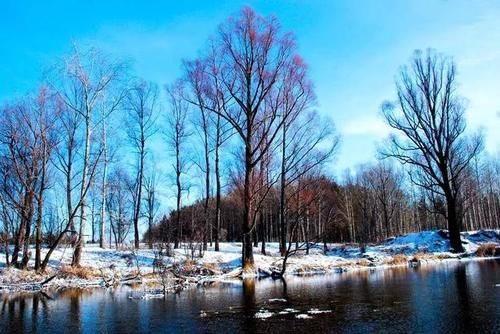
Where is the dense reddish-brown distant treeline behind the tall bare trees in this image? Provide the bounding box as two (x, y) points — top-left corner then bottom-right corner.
(144, 157), (500, 248)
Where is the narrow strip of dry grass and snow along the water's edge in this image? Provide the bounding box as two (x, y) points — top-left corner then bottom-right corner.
(0, 247), (500, 299)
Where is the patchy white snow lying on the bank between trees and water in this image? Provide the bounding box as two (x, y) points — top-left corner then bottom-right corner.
(0, 230), (500, 290)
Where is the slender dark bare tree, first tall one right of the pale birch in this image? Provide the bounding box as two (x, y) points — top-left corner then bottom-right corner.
(126, 81), (158, 248)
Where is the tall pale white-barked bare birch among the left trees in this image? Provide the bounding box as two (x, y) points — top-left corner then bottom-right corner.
(48, 47), (125, 266)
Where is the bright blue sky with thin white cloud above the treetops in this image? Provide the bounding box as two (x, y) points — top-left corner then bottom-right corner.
(0, 0), (500, 173)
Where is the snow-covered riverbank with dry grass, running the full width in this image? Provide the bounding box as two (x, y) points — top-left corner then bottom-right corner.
(0, 230), (500, 293)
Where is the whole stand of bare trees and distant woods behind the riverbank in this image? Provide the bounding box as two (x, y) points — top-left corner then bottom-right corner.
(0, 7), (500, 272)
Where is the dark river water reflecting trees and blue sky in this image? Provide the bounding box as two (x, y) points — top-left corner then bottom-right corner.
(0, 261), (500, 334)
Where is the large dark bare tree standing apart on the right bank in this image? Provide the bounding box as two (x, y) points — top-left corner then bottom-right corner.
(382, 50), (482, 252)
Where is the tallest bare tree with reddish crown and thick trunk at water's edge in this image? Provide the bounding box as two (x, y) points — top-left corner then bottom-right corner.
(186, 7), (312, 272)
